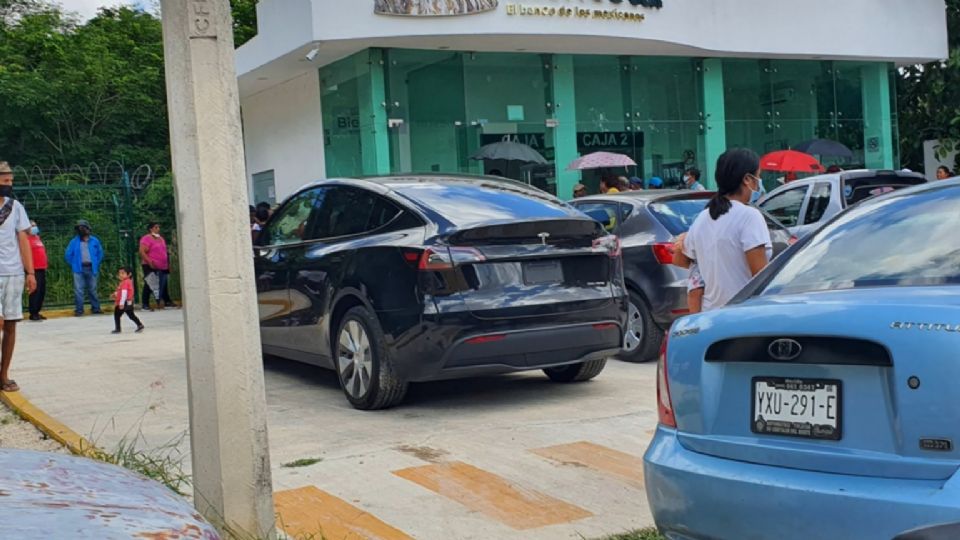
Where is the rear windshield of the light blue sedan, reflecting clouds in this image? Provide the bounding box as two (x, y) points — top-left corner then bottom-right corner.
(762, 187), (960, 295)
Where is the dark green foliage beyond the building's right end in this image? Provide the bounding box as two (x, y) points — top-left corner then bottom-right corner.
(897, 0), (960, 170)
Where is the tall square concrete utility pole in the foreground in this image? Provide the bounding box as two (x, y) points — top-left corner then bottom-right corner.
(161, 0), (276, 538)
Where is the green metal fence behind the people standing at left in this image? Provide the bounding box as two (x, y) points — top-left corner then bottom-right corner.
(14, 162), (180, 307)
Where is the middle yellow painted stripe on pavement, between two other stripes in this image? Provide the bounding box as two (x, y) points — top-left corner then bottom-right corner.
(393, 461), (593, 530)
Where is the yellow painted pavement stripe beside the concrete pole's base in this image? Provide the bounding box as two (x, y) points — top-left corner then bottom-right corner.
(273, 486), (413, 540)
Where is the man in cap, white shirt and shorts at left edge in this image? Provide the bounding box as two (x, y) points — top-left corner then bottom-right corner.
(0, 161), (37, 392)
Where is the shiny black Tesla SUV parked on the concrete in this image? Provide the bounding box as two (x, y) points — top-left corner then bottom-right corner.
(255, 175), (628, 409)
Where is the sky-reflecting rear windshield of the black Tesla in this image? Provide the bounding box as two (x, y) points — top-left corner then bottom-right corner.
(391, 182), (583, 228)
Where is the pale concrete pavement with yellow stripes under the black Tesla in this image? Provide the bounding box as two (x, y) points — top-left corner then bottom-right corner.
(13, 311), (656, 540)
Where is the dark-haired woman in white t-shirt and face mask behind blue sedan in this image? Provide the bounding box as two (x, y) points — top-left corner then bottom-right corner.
(674, 148), (773, 311)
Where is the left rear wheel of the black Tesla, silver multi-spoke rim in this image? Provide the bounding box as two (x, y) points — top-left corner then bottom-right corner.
(333, 306), (408, 410)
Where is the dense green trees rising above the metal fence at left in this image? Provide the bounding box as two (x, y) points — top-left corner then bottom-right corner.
(0, 0), (256, 168)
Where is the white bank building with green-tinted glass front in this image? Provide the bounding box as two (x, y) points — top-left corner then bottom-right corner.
(237, 0), (947, 201)
